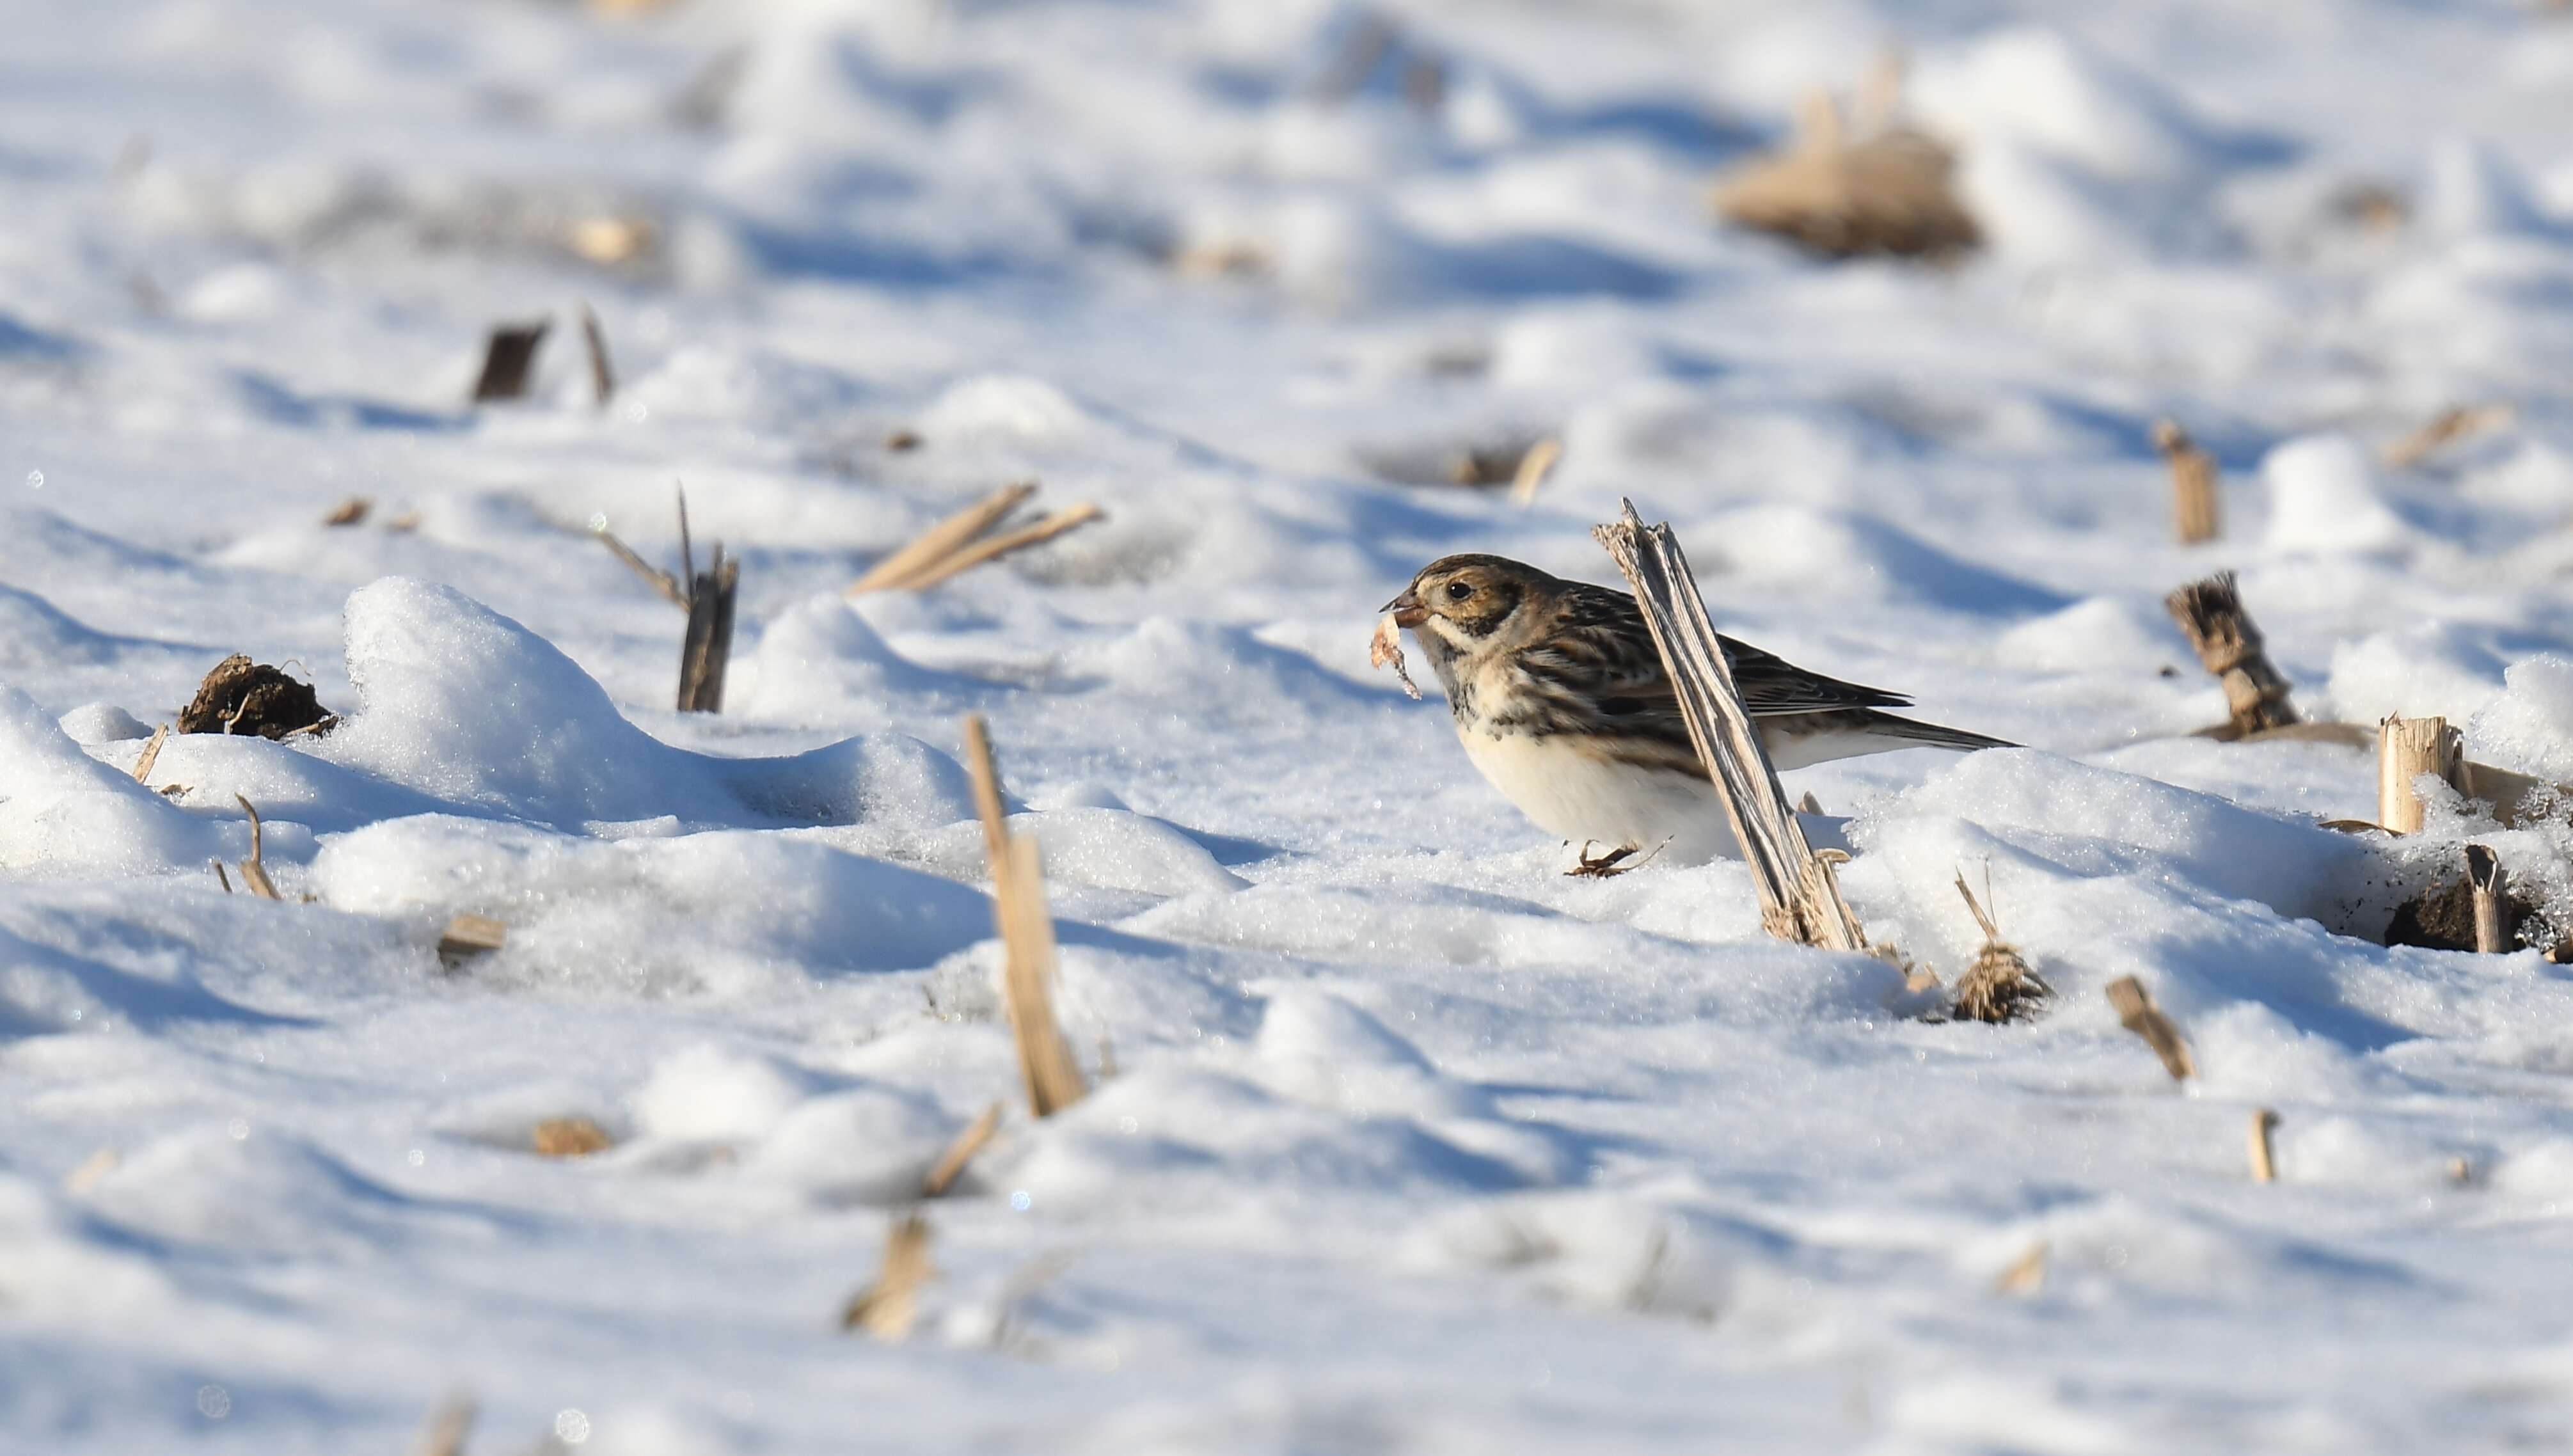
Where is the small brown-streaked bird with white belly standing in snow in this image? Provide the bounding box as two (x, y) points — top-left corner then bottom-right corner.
(1382, 556), (2017, 874)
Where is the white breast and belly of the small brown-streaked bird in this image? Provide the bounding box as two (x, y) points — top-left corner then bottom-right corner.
(1456, 728), (1737, 864)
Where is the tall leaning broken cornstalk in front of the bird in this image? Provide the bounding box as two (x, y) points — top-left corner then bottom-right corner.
(1590, 502), (1868, 952)
